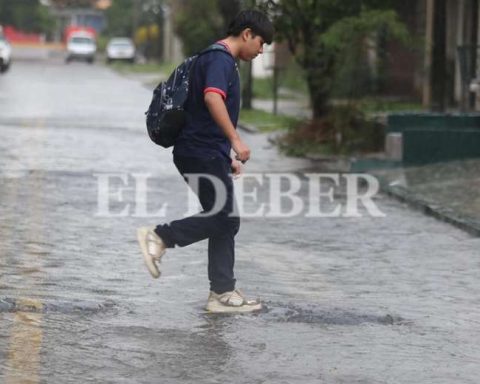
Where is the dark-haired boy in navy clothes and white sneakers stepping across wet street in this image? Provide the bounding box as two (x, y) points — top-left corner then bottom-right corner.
(137, 10), (273, 313)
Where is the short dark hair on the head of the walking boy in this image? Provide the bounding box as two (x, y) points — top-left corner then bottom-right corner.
(227, 9), (274, 44)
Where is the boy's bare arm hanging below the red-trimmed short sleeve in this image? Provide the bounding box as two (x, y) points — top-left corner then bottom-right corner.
(204, 92), (250, 162)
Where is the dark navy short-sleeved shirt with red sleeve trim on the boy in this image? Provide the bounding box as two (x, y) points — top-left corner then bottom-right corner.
(173, 44), (240, 162)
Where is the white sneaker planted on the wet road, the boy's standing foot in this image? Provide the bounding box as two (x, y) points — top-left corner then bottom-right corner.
(206, 289), (262, 313)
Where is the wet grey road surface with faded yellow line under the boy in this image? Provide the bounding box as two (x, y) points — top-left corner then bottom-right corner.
(0, 55), (480, 384)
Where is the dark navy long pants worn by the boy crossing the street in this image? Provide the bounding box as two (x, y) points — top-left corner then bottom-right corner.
(155, 156), (240, 293)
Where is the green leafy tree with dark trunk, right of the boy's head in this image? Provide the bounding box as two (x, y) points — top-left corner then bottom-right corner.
(261, 0), (407, 119)
